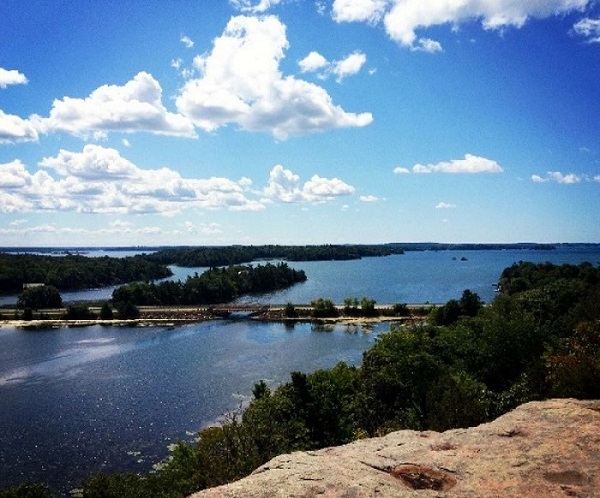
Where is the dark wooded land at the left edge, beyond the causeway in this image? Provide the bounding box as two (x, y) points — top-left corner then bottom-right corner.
(0, 253), (172, 293)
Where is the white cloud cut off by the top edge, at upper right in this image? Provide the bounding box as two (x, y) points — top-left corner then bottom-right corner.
(332, 0), (595, 52)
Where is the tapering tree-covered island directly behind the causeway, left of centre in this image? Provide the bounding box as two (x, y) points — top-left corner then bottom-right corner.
(112, 263), (306, 306)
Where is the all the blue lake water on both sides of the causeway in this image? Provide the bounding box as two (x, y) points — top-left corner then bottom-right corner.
(0, 246), (600, 493)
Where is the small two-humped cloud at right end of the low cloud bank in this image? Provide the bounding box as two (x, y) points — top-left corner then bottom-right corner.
(263, 164), (355, 203)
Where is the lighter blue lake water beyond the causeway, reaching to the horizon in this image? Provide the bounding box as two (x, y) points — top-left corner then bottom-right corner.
(0, 245), (600, 305)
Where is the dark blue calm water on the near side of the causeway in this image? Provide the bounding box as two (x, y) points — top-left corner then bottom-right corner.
(0, 321), (387, 493)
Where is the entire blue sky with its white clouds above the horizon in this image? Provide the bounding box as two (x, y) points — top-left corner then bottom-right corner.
(0, 0), (600, 247)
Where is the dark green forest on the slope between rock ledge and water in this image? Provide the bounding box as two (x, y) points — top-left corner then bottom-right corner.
(0, 262), (600, 498)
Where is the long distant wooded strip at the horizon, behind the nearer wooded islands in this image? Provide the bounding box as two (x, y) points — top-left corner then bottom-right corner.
(146, 244), (402, 267)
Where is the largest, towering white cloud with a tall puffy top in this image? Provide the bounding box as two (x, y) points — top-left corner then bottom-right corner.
(176, 16), (373, 140)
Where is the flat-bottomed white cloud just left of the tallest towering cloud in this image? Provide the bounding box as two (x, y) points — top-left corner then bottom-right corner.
(32, 72), (195, 137)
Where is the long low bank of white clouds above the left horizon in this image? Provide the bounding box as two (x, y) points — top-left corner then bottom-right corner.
(0, 144), (354, 215)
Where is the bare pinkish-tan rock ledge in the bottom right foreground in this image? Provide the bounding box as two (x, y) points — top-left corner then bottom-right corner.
(193, 399), (600, 498)
